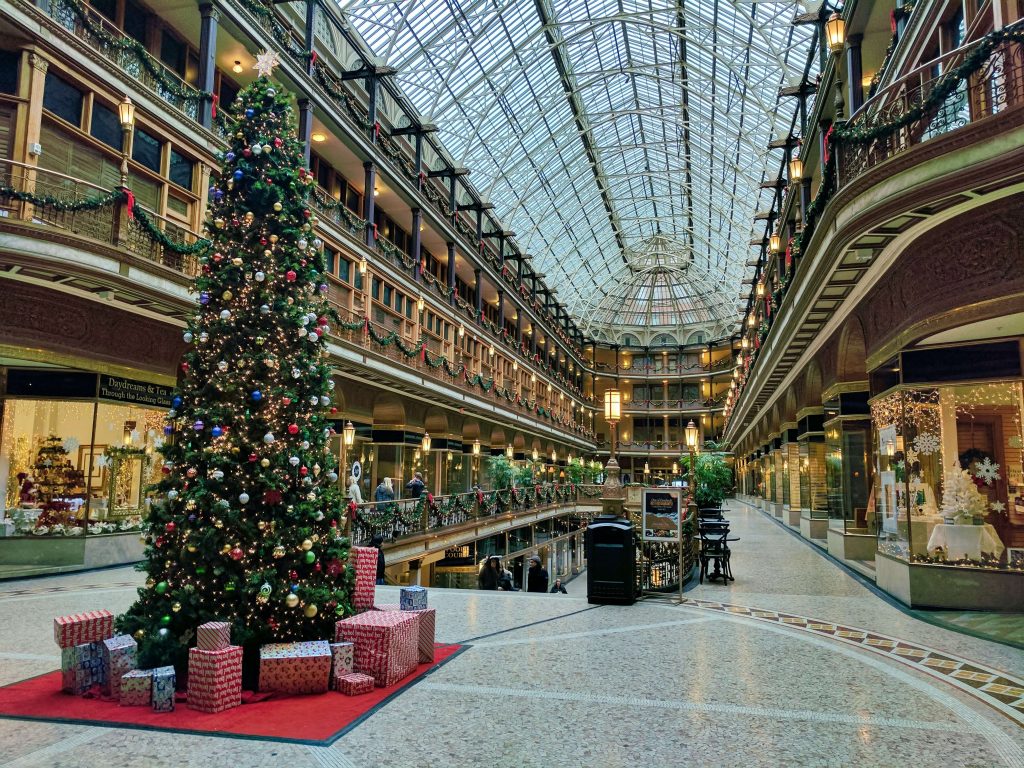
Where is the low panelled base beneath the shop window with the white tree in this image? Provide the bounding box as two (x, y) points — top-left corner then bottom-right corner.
(874, 552), (1024, 611)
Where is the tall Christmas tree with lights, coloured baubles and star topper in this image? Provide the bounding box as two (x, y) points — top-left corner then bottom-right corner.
(119, 54), (353, 672)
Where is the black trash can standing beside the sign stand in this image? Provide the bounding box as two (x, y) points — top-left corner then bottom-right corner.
(584, 515), (637, 605)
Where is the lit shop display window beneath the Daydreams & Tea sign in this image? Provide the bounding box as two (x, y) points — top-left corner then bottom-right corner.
(0, 398), (165, 536)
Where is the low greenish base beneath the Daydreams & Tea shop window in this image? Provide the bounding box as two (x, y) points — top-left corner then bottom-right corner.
(0, 530), (144, 579)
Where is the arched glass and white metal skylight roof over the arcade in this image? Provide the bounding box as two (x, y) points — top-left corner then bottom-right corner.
(340, 0), (816, 341)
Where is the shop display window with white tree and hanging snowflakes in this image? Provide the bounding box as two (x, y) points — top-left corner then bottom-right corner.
(868, 381), (1024, 570)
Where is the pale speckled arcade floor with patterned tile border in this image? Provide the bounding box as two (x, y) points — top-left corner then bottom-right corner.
(0, 506), (1024, 768)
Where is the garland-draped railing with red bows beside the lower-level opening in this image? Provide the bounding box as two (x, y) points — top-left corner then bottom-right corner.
(348, 483), (582, 542)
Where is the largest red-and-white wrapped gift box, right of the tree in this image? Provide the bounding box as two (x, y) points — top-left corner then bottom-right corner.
(335, 610), (419, 687)
